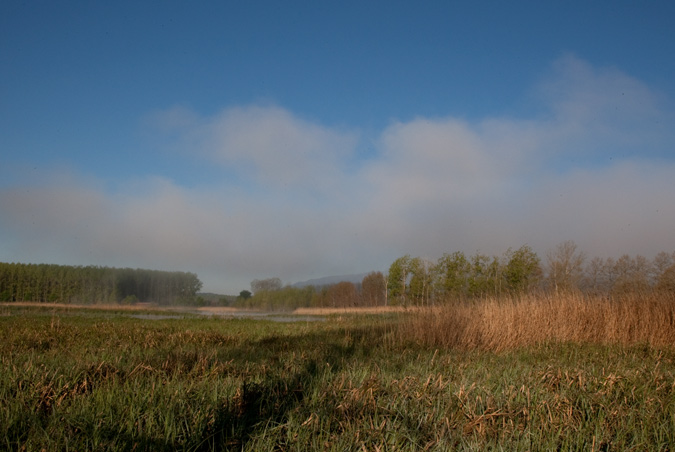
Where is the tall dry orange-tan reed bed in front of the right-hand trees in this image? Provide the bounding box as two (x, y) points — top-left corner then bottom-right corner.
(398, 293), (675, 351)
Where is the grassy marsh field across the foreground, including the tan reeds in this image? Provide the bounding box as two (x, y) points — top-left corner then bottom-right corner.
(0, 297), (675, 451)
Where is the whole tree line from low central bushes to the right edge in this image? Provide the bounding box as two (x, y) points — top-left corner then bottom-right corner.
(235, 241), (675, 309)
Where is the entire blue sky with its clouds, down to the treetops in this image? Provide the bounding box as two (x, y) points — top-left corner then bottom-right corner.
(0, 0), (675, 294)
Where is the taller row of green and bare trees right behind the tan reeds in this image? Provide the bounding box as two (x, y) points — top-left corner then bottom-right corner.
(388, 241), (675, 305)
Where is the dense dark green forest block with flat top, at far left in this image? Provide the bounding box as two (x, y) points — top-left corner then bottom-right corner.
(0, 263), (202, 305)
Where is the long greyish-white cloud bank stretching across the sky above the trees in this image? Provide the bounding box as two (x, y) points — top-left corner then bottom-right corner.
(0, 57), (675, 293)
